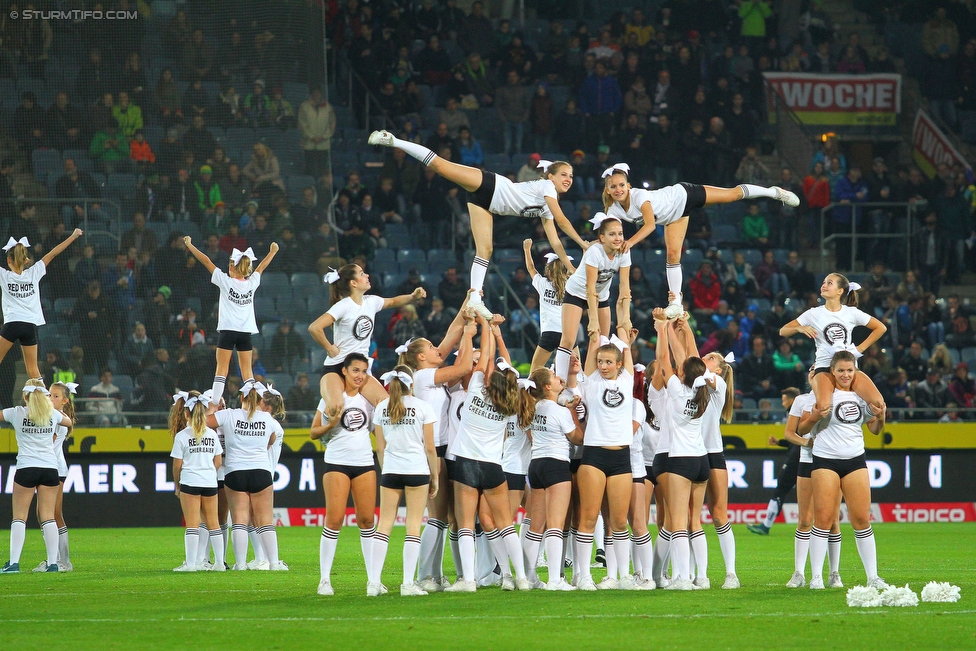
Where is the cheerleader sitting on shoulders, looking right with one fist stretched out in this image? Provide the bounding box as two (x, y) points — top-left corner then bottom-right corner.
(308, 264), (427, 429)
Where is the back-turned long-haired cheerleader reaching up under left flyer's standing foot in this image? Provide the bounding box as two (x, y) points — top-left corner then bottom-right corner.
(445, 314), (534, 592)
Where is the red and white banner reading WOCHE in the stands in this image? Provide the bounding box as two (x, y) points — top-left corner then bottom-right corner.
(763, 72), (901, 126)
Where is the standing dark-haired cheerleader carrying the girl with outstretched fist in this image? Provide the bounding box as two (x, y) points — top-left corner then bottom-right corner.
(311, 353), (376, 596)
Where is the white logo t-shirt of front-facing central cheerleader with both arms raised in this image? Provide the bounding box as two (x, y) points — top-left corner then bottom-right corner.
(583, 369), (634, 446)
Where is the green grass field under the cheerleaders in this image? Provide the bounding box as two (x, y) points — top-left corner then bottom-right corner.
(0, 524), (976, 650)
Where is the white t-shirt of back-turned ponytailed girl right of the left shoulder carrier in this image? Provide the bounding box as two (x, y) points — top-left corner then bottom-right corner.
(373, 396), (438, 475)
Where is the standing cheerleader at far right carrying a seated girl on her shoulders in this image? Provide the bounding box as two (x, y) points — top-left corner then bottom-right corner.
(797, 350), (888, 590)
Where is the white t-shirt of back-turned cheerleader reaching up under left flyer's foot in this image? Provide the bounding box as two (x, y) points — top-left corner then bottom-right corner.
(453, 371), (513, 465)
